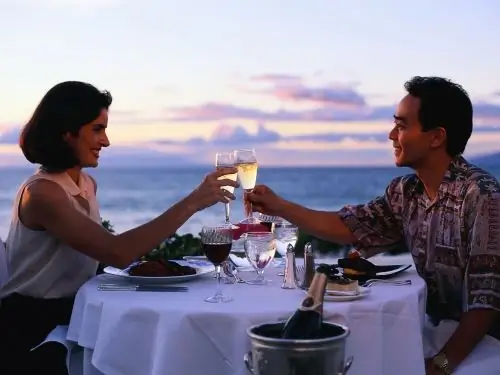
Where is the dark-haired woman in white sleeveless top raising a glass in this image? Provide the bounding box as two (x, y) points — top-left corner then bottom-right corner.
(0, 82), (237, 375)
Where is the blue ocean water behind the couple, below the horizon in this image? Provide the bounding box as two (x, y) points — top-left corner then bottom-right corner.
(0, 167), (500, 239)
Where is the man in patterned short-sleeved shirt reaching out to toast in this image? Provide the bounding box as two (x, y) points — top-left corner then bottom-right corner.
(247, 77), (500, 375)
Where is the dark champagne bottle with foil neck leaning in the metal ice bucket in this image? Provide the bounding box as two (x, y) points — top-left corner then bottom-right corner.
(281, 265), (330, 340)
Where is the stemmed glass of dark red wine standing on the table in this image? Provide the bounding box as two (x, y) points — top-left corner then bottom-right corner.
(201, 225), (233, 303)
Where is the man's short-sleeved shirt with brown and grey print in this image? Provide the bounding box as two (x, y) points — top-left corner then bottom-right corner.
(339, 156), (500, 339)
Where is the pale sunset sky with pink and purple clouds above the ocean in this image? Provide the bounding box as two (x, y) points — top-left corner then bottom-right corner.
(0, 0), (500, 165)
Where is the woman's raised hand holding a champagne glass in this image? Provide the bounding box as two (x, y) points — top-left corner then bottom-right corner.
(189, 168), (239, 211)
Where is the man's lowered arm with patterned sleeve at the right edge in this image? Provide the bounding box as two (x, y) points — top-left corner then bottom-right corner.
(432, 188), (500, 370)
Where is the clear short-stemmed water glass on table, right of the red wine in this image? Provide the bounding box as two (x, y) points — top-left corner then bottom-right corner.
(244, 232), (276, 285)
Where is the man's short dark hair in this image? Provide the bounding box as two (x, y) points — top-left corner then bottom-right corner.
(405, 76), (473, 157)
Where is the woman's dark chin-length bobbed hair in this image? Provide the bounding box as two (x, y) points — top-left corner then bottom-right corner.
(19, 81), (113, 171)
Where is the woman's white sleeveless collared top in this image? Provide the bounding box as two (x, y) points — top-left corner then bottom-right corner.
(0, 170), (101, 298)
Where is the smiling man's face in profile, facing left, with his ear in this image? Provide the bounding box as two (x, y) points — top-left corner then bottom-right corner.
(389, 95), (443, 169)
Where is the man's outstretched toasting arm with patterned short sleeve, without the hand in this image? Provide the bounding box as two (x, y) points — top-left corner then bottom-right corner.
(278, 179), (403, 257)
